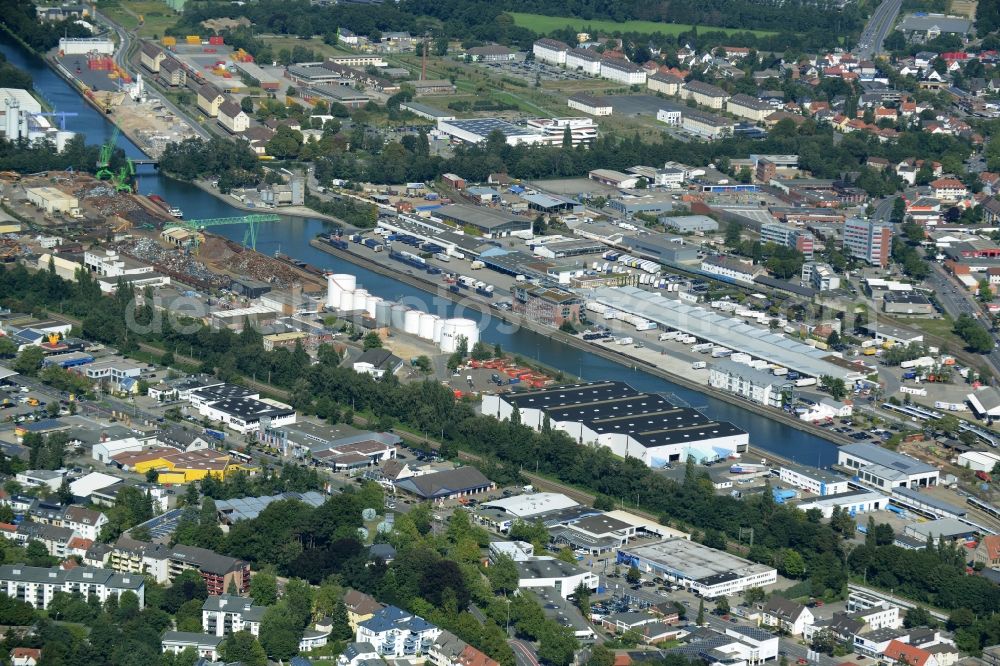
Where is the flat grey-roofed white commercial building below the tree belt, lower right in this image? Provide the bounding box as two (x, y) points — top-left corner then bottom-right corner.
(618, 539), (778, 599)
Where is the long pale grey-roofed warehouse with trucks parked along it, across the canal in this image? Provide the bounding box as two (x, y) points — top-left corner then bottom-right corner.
(590, 287), (867, 382)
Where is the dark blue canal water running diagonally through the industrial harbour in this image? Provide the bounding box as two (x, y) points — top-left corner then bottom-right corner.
(0, 33), (837, 467)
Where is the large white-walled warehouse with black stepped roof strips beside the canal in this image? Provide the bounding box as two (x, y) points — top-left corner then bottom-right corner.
(483, 381), (749, 467)
